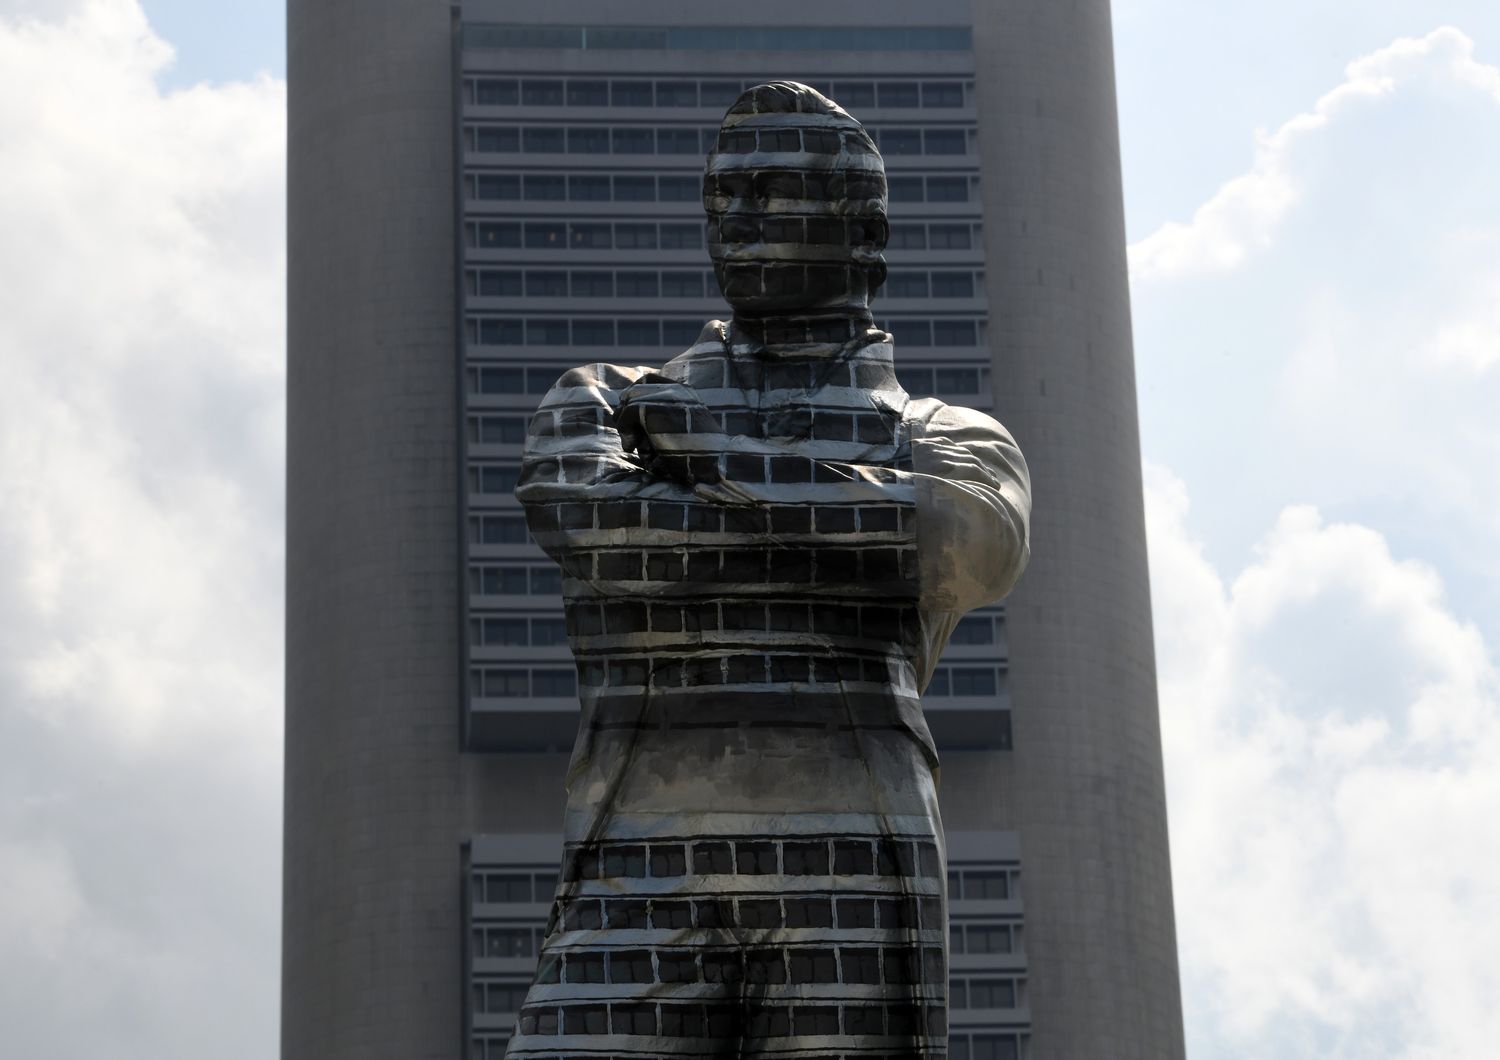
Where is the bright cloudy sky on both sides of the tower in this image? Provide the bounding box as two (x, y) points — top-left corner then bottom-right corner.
(0, 0), (1500, 1060)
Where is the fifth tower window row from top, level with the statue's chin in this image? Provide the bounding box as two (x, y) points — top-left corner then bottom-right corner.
(465, 268), (983, 298)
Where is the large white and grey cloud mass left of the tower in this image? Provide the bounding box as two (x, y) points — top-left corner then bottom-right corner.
(0, 0), (285, 1057)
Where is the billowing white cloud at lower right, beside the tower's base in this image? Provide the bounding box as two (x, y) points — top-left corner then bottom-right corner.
(1148, 468), (1500, 1060)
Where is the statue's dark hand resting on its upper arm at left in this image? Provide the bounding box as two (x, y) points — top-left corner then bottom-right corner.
(615, 372), (726, 486)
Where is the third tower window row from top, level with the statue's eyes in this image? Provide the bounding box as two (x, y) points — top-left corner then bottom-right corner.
(465, 172), (980, 202)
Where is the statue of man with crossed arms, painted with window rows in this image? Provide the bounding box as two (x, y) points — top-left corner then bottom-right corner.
(509, 82), (1031, 1060)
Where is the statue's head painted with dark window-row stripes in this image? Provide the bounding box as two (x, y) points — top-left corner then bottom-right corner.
(704, 81), (890, 318)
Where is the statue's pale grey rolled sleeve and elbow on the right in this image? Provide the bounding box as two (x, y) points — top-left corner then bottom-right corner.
(908, 399), (1031, 621)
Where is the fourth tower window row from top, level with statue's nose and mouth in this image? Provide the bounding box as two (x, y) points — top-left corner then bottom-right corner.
(464, 220), (981, 250)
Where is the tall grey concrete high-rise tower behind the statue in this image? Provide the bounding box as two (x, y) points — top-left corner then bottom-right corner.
(282, 0), (1182, 1060)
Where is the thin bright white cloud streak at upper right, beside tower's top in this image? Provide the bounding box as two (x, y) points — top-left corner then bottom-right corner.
(1130, 27), (1500, 286)
